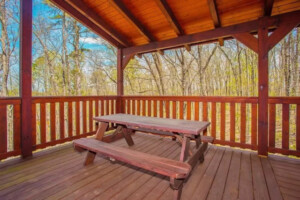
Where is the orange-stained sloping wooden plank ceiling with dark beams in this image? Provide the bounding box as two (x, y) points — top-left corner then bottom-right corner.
(51, 0), (300, 48)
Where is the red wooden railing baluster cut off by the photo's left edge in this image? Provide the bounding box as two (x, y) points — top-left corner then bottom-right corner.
(0, 105), (7, 153)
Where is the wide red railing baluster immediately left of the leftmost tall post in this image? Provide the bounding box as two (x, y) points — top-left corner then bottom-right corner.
(13, 104), (21, 151)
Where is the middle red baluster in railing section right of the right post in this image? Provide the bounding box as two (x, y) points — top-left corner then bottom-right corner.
(282, 104), (290, 149)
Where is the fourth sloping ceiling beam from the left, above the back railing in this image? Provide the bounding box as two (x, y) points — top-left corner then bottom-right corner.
(155, 0), (184, 36)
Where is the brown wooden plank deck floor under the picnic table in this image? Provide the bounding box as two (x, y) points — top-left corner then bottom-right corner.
(0, 133), (300, 200)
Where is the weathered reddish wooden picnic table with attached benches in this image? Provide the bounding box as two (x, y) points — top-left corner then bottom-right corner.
(74, 114), (213, 199)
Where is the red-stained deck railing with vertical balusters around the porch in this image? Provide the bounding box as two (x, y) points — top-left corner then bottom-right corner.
(0, 96), (300, 160)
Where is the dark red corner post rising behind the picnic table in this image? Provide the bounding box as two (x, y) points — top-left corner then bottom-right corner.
(116, 49), (124, 113)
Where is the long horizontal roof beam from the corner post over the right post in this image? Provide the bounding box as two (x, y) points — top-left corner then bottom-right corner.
(124, 11), (300, 55)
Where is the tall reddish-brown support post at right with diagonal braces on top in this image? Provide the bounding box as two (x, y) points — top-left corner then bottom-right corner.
(258, 18), (269, 156)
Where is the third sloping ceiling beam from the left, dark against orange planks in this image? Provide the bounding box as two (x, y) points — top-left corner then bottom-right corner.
(108, 0), (155, 42)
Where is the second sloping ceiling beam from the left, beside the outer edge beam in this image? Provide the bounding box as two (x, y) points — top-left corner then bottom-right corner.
(66, 0), (131, 47)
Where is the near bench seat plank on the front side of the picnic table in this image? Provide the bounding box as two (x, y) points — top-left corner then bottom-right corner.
(74, 138), (192, 179)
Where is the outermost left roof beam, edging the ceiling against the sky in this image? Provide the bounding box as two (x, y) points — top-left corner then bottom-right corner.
(51, 0), (124, 48)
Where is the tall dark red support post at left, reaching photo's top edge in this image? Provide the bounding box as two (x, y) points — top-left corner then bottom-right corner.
(20, 0), (32, 157)
